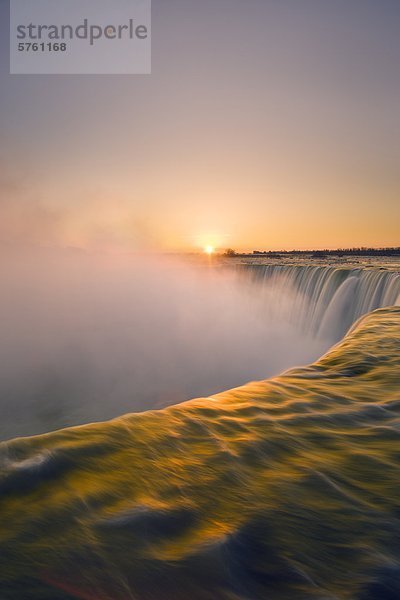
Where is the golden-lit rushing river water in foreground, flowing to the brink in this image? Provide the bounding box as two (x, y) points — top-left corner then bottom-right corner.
(0, 308), (400, 600)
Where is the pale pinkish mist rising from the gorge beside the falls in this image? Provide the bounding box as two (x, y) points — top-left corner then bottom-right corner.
(0, 248), (327, 439)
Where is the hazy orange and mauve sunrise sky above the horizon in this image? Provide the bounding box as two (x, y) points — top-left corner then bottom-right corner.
(0, 0), (400, 252)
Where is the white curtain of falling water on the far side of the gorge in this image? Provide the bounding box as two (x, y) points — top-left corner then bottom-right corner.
(239, 264), (400, 341)
